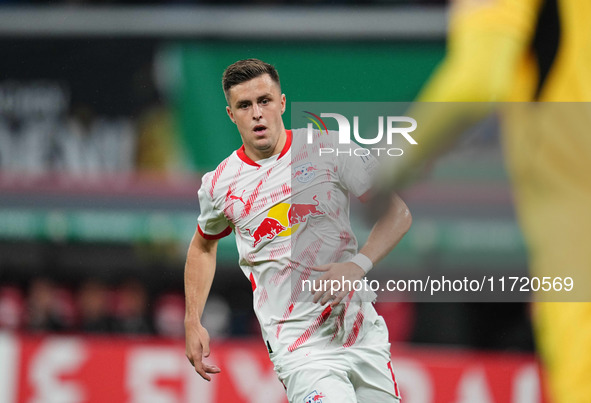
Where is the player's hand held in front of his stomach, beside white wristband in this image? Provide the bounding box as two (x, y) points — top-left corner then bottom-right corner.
(312, 262), (365, 307)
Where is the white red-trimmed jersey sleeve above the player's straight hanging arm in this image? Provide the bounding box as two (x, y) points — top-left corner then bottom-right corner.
(197, 172), (232, 240)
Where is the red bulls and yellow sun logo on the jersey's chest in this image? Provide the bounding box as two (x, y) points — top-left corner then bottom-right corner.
(246, 195), (324, 247)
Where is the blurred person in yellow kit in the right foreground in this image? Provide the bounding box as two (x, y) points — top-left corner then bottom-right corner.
(382, 0), (591, 403)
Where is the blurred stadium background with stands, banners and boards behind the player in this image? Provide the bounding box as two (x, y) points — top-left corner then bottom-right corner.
(0, 0), (543, 403)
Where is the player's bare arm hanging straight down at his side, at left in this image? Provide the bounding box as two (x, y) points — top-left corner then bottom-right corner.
(185, 231), (220, 381)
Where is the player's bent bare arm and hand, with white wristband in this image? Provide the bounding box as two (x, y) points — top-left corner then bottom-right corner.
(313, 194), (412, 307)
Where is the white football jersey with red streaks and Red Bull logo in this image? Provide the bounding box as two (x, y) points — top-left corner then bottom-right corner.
(198, 129), (377, 355)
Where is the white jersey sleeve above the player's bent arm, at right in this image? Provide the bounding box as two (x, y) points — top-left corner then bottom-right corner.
(336, 134), (378, 197)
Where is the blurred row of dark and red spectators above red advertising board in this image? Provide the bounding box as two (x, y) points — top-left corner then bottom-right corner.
(0, 277), (533, 351)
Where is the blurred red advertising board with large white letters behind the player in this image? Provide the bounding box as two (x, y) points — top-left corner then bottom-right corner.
(0, 333), (544, 403)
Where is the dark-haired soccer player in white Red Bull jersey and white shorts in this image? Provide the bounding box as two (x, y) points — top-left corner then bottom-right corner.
(185, 59), (411, 403)
